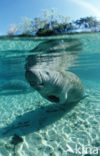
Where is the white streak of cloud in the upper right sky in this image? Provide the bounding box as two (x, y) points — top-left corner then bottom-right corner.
(72, 0), (100, 18)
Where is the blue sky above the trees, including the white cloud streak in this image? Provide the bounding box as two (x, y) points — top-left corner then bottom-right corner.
(0, 0), (100, 35)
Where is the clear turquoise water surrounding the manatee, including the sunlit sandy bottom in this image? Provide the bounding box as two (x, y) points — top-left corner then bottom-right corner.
(0, 33), (100, 156)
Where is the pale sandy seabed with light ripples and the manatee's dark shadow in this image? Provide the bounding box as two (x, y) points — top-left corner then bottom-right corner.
(0, 81), (100, 156)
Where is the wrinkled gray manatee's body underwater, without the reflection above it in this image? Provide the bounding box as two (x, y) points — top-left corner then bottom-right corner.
(26, 67), (83, 104)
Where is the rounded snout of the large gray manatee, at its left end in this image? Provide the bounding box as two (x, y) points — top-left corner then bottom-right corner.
(25, 68), (42, 90)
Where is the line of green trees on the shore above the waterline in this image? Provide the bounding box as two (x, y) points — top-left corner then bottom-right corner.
(8, 9), (100, 36)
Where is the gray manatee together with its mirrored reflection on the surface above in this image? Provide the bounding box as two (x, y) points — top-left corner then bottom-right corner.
(25, 39), (84, 104)
